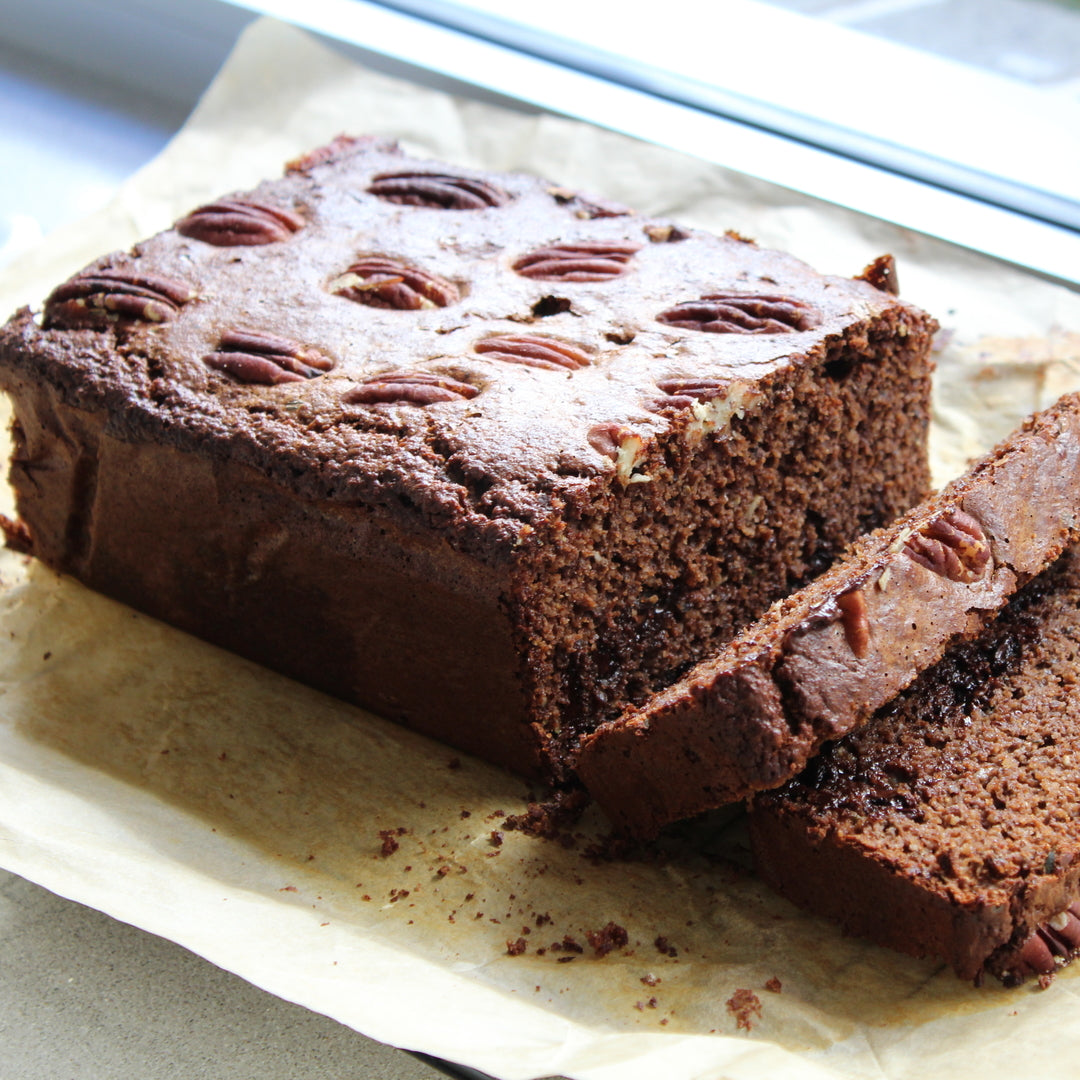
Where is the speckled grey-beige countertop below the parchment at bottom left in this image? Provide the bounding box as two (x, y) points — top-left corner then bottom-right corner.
(0, 870), (455, 1080)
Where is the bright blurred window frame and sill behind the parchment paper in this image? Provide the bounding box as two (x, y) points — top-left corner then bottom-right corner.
(0, 0), (1080, 284)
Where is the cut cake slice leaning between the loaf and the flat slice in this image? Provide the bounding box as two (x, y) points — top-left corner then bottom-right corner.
(577, 395), (1080, 836)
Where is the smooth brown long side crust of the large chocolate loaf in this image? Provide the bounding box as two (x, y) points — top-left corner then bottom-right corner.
(0, 383), (543, 773)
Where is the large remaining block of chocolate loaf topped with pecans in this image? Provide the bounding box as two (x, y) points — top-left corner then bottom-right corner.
(0, 137), (934, 775)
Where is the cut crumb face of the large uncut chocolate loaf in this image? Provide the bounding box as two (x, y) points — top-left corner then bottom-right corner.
(535, 312), (932, 784)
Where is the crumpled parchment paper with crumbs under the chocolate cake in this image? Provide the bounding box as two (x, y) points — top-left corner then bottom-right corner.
(6, 22), (1080, 1080)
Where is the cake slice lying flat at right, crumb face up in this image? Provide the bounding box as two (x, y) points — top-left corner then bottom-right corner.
(751, 546), (1080, 984)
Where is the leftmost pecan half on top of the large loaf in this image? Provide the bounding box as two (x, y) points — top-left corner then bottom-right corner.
(43, 267), (195, 329)
